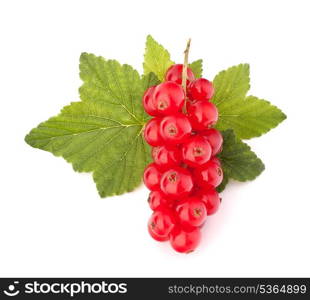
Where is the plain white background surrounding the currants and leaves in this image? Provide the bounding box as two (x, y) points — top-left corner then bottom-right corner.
(0, 0), (310, 277)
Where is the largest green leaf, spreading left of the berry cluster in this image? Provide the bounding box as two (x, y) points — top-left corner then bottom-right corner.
(25, 53), (156, 197)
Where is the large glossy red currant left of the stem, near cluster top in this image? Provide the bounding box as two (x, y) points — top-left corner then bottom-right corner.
(153, 81), (185, 116)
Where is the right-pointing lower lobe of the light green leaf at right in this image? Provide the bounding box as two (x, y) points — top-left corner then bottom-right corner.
(216, 96), (286, 139)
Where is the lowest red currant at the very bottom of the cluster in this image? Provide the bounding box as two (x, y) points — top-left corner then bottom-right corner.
(170, 226), (201, 253)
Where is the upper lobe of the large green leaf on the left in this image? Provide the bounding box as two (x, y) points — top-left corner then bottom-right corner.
(80, 53), (146, 123)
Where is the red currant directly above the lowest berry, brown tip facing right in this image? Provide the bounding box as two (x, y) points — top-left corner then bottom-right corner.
(176, 197), (207, 227)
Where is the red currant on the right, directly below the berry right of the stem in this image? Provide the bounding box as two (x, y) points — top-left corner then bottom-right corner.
(187, 101), (218, 130)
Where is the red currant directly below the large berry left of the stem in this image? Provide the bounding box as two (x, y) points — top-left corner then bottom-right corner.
(159, 113), (192, 145)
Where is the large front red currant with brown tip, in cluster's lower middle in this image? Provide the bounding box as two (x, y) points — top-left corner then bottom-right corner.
(160, 167), (194, 199)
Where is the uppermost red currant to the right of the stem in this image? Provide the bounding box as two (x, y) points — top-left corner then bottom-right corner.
(188, 78), (214, 101)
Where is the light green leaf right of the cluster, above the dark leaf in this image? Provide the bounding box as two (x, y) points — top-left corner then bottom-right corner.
(212, 64), (286, 139)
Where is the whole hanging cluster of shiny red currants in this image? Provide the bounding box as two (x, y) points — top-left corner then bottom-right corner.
(143, 64), (223, 253)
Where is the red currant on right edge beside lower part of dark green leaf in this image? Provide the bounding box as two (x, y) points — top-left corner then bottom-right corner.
(194, 161), (223, 189)
